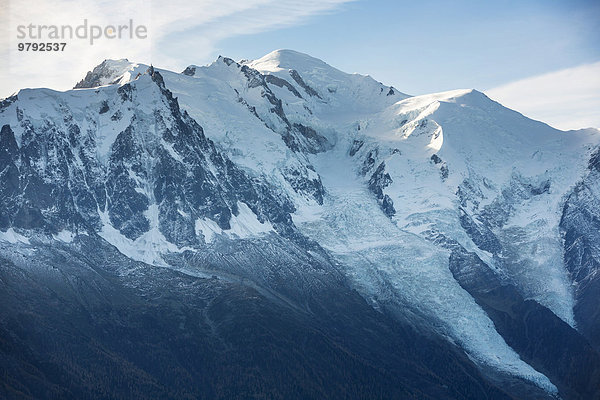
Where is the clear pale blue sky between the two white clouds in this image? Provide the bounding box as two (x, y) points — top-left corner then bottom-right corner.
(214, 0), (600, 94)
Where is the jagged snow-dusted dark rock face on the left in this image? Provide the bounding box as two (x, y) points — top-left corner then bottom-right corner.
(0, 71), (293, 242)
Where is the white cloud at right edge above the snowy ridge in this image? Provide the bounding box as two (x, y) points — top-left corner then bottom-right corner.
(486, 62), (600, 130)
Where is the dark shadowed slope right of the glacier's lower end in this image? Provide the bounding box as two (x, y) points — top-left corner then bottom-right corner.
(450, 247), (600, 399)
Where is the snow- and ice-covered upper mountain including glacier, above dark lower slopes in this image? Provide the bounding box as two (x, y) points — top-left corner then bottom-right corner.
(0, 50), (600, 392)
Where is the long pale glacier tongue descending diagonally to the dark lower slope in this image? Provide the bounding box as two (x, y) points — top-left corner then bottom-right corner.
(294, 145), (557, 393)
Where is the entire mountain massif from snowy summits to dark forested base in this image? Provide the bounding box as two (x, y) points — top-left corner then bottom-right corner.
(0, 50), (600, 399)
